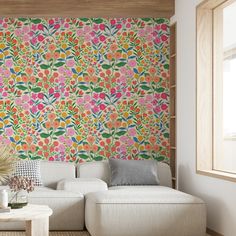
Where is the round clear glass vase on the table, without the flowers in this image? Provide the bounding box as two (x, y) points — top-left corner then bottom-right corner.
(8, 190), (28, 209)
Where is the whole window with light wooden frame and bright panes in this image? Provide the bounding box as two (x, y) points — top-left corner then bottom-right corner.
(197, 0), (236, 180)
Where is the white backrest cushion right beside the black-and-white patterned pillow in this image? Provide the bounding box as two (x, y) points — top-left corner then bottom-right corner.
(40, 161), (75, 189)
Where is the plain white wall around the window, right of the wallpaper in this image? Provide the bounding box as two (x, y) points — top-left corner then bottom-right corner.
(172, 0), (236, 236)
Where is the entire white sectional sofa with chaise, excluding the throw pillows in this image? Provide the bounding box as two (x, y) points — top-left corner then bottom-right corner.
(0, 161), (206, 236)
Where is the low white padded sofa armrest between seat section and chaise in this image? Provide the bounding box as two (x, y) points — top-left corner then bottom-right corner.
(57, 178), (108, 195)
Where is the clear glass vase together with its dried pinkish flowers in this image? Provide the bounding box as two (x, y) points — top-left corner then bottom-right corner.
(8, 176), (34, 209)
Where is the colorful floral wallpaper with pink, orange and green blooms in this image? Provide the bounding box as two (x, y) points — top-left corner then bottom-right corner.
(0, 18), (169, 162)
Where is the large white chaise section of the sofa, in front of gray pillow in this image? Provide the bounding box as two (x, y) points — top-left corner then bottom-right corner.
(85, 186), (206, 236)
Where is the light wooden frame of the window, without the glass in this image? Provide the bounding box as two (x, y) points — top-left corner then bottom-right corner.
(196, 0), (236, 182)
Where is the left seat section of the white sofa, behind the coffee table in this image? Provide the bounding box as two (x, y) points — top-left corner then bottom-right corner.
(0, 187), (84, 230)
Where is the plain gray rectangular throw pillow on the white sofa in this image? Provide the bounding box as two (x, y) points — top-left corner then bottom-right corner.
(109, 158), (160, 186)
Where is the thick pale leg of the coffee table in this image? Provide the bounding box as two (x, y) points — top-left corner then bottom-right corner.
(26, 217), (49, 236)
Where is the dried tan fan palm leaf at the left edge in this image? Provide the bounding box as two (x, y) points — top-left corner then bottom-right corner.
(0, 142), (15, 185)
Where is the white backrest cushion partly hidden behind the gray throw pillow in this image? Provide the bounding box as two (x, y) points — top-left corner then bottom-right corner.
(77, 161), (172, 187)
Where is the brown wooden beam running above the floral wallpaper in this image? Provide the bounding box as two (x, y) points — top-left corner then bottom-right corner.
(0, 0), (175, 18)
